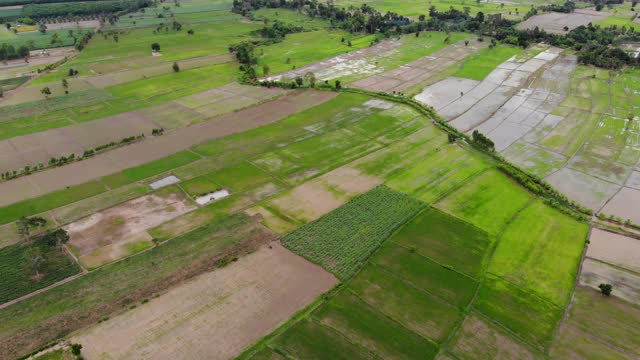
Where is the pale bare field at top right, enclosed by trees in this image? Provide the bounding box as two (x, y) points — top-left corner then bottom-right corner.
(516, 9), (610, 34)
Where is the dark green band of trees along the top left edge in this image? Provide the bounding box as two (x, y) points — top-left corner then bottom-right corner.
(22, 0), (153, 18)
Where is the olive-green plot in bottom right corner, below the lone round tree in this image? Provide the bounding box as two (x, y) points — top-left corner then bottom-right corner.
(567, 286), (640, 359)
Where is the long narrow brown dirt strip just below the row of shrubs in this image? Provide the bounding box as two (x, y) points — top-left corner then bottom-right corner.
(0, 91), (336, 206)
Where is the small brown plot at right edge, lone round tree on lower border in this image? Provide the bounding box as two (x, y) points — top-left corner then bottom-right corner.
(580, 258), (640, 305)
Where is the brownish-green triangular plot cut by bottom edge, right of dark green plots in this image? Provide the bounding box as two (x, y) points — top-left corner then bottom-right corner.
(449, 313), (544, 360)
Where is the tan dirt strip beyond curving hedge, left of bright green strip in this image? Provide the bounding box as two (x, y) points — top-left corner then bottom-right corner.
(351, 41), (486, 92)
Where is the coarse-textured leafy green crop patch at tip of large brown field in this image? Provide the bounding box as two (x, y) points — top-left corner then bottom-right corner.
(283, 186), (424, 280)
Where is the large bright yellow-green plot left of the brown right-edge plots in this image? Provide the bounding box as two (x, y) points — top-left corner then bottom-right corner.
(489, 200), (588, 307)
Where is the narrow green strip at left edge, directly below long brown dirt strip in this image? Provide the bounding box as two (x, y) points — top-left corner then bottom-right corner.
(0, 181), (107, 224)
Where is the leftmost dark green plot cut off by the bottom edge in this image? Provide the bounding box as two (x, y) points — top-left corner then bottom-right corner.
(272, 319), (372, 360)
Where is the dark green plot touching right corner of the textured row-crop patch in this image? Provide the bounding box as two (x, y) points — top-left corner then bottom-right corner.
(392, 208), (492, 278)
